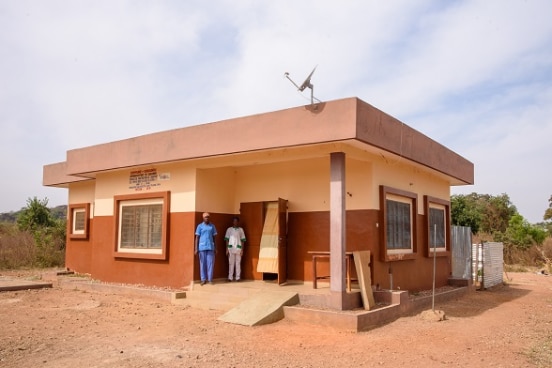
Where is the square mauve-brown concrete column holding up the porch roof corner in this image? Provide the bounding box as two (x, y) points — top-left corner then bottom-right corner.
(330, 152), (346, 296)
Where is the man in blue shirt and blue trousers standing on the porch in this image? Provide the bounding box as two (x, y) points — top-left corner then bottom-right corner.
(195, 212), (217, 285)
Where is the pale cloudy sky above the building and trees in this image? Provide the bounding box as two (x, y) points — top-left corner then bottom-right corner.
(0, 0), (552, 223)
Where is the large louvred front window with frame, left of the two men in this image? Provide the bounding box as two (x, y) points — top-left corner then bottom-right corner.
(115, 192), (169, 259)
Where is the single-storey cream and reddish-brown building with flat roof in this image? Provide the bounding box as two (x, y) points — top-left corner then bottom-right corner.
(43, 98), (474, 309)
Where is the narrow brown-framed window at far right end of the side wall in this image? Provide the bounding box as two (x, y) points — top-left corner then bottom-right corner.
(424, 196), (450, 256)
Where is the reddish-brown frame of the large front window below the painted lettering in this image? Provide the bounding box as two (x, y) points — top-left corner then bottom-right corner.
(113, 191), (170, 260)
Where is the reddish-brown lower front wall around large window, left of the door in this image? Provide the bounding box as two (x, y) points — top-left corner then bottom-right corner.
(76, 212), (237, 288)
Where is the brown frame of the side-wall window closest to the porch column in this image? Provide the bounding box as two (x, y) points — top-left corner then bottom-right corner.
(380, 185), (418, 262)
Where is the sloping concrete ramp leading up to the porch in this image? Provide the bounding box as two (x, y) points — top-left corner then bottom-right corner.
(218, 291), (299, 326)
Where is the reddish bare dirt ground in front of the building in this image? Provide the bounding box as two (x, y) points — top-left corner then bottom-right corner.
(0, 273), (552, 367)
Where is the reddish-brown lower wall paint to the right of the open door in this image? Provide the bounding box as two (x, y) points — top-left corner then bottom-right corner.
(286, 210), (451, 291)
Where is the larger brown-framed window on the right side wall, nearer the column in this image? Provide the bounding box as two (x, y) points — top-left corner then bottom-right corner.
(380, 186), (417, 261)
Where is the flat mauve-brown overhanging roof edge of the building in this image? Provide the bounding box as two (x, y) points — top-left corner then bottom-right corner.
(43, 97), (474, 186)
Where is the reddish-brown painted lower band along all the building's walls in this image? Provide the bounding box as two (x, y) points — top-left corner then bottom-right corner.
(66, 208), (451, 291)
